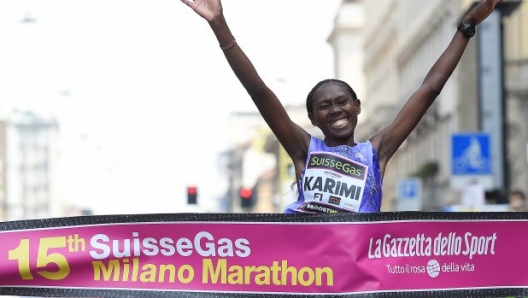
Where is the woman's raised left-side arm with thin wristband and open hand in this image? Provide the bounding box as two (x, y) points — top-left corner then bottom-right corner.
(181, 0), (310, 156)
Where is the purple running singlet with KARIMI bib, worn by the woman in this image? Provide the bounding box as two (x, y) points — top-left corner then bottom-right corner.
(284, 136), (382, 214)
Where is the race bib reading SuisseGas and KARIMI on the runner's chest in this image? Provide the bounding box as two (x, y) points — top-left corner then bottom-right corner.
(298, 152), (368, 213)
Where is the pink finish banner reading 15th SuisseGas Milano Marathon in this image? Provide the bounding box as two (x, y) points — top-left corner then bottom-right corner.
(0, 212), (528, 297)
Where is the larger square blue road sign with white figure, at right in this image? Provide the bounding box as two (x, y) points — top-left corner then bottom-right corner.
(451, 133), (492, 175)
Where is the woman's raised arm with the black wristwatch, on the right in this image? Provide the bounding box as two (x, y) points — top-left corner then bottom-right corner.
(371, 0), (502, 170)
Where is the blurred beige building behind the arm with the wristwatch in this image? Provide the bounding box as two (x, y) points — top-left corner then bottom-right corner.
(364, 0), (468, 210)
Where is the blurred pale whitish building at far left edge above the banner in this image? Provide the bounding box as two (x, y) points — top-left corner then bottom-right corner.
(0, 112), (63, 221)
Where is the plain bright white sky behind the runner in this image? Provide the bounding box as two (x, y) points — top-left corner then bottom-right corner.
(0, 0), (341, 214)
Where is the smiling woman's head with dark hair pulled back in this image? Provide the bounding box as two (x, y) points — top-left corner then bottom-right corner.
(308, 81), (361, 146)
